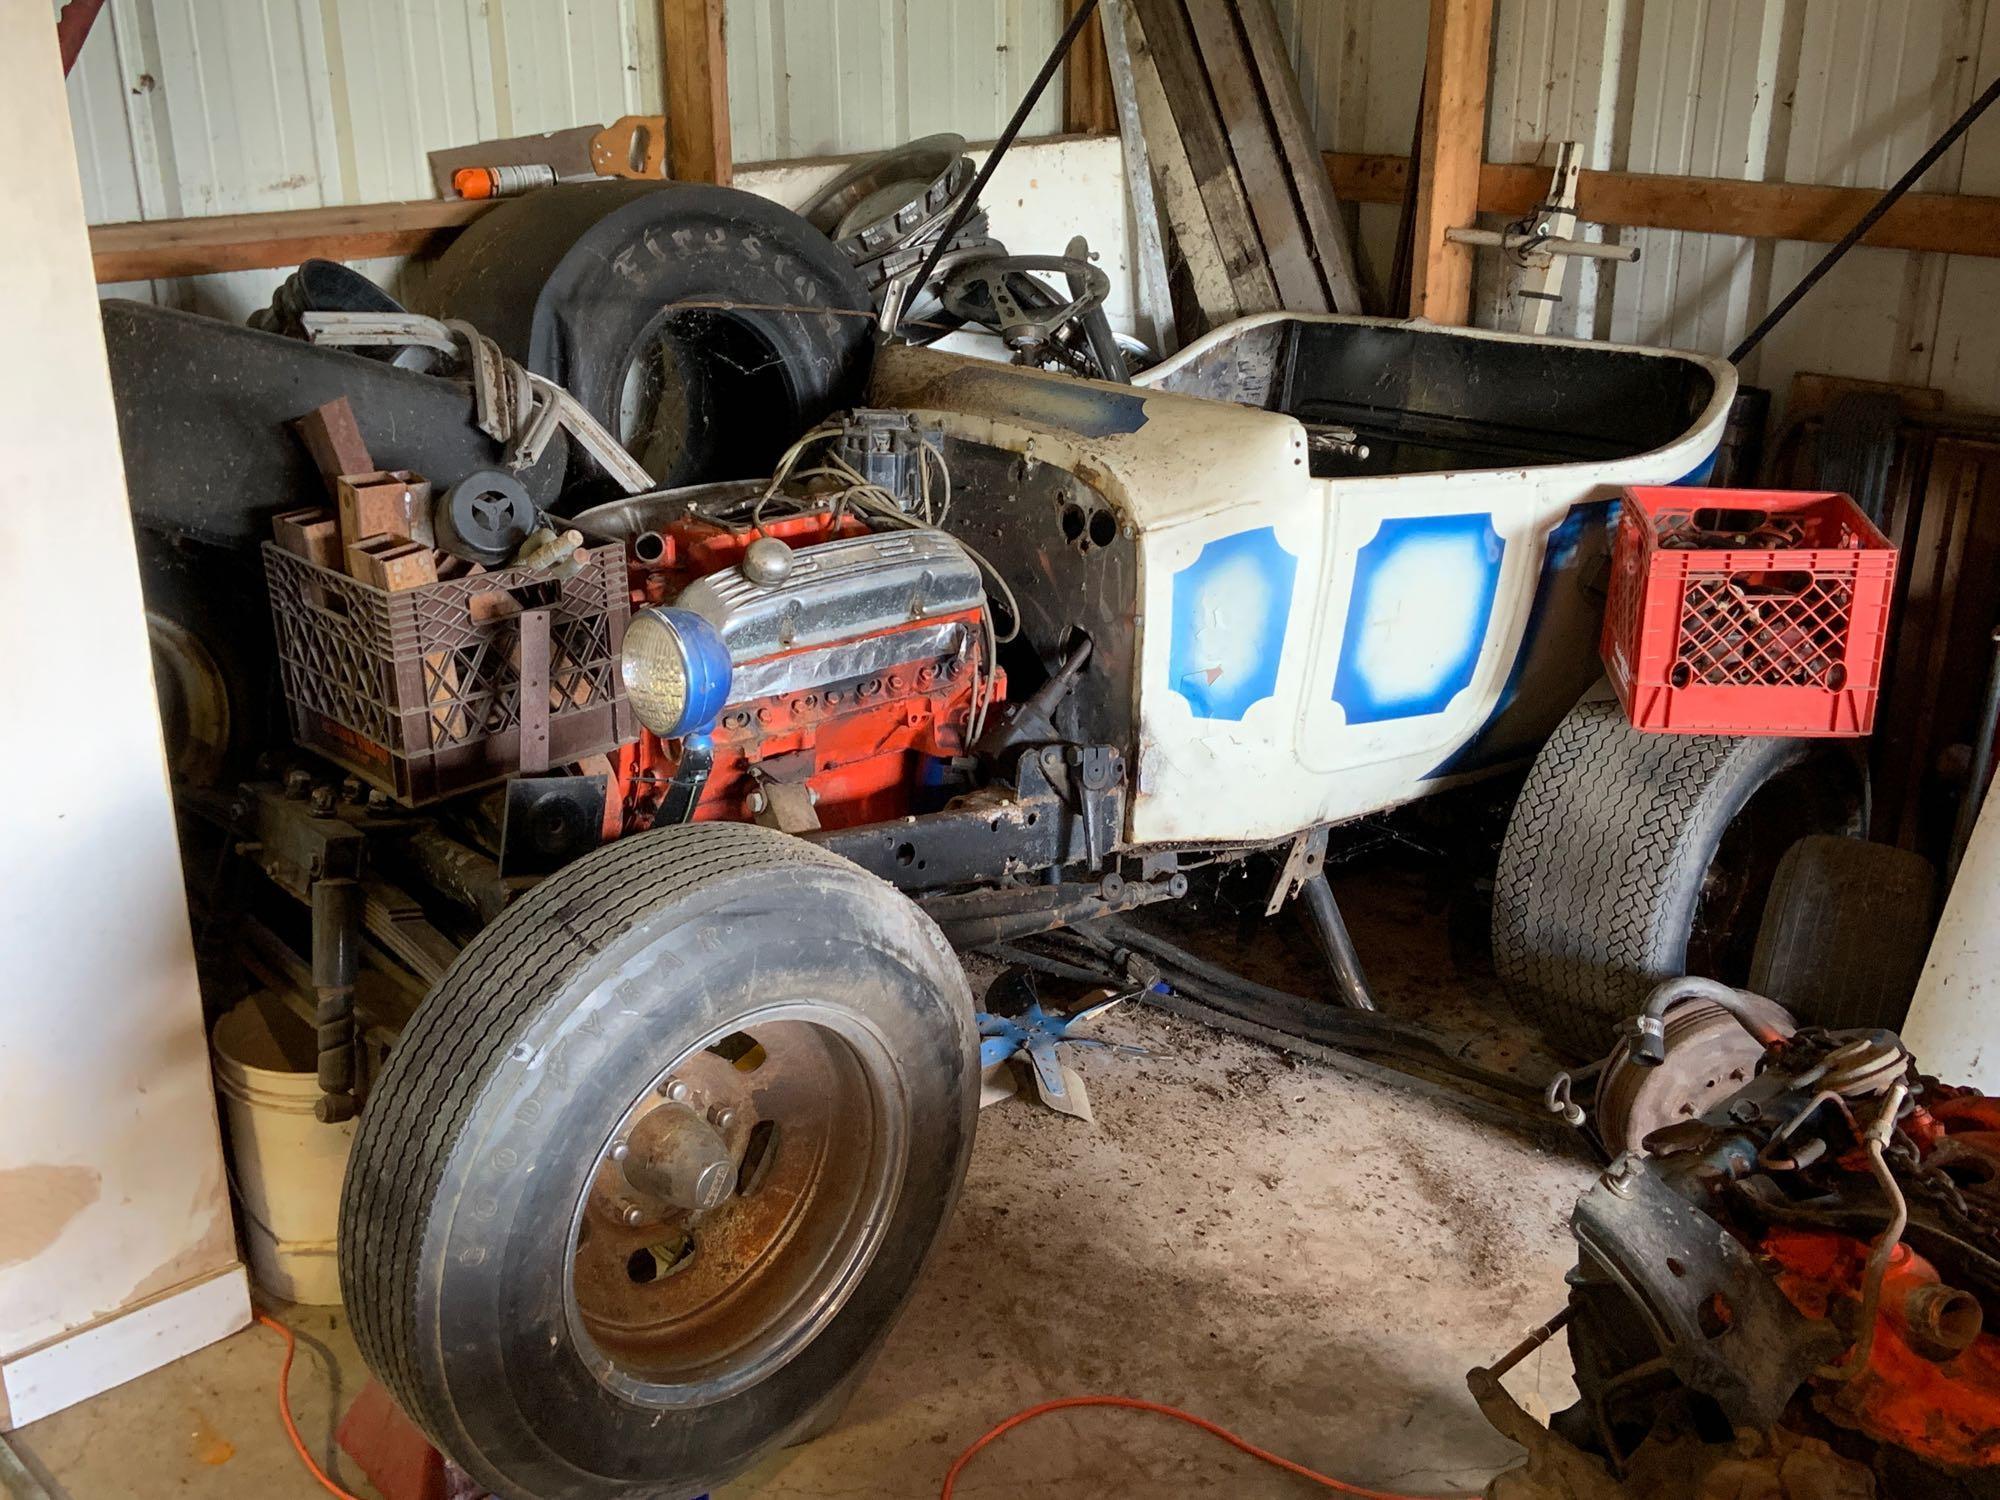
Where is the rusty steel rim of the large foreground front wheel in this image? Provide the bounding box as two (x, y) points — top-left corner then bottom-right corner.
(564, 1002), (908, 1406)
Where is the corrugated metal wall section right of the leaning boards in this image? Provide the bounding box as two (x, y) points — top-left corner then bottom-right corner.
(1276, 0), (2000, 410)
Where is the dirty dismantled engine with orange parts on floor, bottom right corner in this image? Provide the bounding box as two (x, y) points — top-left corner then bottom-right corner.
(1472, 980), (2000, 1500)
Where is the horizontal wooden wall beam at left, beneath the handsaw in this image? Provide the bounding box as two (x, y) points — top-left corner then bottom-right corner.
(90, 198), (494, 282)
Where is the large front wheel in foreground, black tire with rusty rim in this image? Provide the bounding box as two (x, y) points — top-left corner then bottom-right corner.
(340, 824), (978, 1500)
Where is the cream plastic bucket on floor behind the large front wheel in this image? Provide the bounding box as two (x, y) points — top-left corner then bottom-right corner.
(210, 990), (354, 1306)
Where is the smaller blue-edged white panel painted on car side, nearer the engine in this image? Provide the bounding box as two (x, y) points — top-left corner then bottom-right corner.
(1166, 526), (1298, 718)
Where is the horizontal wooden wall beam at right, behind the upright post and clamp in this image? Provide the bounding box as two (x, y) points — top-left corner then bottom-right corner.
(1326, 152), (2000, 256)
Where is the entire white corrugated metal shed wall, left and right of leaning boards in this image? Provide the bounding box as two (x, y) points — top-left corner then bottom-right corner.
(70, 0), (2000, 408)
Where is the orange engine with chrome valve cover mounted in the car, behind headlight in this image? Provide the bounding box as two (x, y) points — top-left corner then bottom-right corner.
(582, 428), (1006, 834)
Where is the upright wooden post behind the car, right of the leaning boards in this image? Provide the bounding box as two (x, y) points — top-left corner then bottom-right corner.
(1410, 0), (1494, 324)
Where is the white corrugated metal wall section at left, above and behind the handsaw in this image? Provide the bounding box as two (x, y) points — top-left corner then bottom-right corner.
(52, 0), (1062, 316)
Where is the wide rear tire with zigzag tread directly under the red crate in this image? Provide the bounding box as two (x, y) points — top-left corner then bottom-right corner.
(1492, 700), (1860, 1056)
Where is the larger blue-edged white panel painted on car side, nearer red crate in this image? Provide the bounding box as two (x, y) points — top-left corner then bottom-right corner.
(1334, 512), (1506, 724)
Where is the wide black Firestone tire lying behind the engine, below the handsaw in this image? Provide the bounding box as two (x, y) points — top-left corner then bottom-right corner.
(424, 182), (874, 488)
